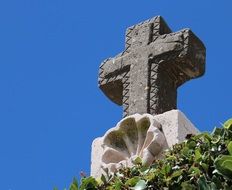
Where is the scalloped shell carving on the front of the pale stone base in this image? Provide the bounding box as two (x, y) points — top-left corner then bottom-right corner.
(101, 114), (168, 172)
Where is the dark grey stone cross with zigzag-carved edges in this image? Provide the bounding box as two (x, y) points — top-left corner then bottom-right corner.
(98, 16), (205, 117)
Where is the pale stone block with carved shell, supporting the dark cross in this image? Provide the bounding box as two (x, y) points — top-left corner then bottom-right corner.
(91, 110), (199, 177)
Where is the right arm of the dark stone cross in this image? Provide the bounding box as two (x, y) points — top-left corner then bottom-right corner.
(146, 29), (206, 86)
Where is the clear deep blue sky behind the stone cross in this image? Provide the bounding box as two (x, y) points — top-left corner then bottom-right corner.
(0, 0), (232, 190)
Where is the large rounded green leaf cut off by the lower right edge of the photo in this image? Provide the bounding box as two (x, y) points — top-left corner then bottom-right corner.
(214, 155), (232, 179)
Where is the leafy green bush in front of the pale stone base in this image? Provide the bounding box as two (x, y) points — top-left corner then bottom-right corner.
(59, 119), (232, 190)
